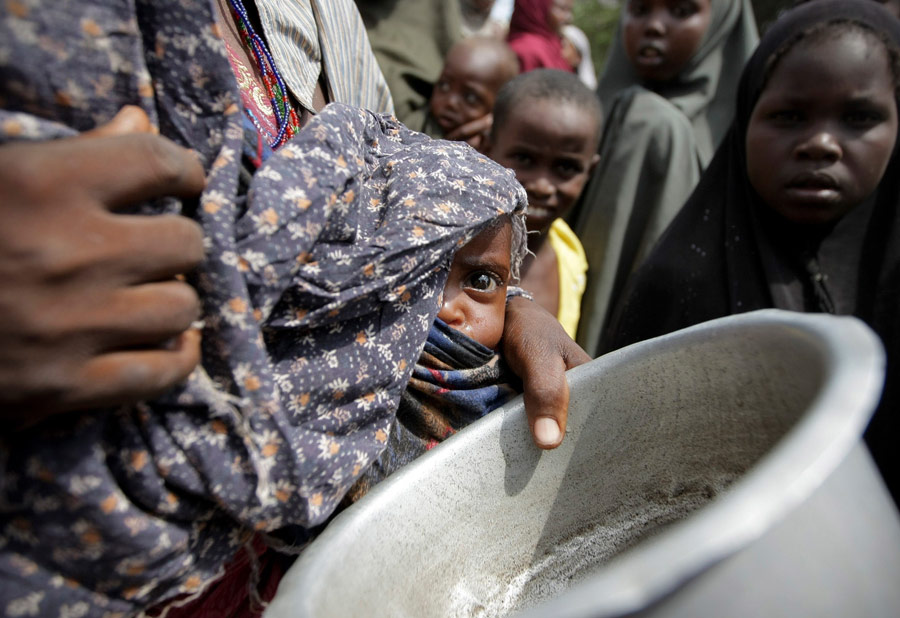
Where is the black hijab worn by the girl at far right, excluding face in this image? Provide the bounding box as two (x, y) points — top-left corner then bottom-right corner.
(601, 0), (900, 496)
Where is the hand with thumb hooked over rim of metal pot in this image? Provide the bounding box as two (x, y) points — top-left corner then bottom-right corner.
(503, 297), (591, 449)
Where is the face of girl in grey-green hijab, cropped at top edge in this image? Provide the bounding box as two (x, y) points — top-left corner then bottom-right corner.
(622, 0), (710, 82)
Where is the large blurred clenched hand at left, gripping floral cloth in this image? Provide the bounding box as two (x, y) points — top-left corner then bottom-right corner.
(0, 108), (205, 428)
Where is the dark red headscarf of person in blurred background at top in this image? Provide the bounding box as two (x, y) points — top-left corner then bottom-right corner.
(506, 0), (573, 73)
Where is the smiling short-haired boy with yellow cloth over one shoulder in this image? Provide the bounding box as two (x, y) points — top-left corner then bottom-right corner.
(486, 69), (602, 335)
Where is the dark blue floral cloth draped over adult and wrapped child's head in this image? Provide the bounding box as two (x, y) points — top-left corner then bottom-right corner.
(0, 0), (526, 616)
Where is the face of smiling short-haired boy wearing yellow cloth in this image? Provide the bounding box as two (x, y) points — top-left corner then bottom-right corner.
(488, 99), (599, 234)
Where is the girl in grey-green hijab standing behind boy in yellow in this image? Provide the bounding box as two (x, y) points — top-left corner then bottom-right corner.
(569, 0), (757, 356)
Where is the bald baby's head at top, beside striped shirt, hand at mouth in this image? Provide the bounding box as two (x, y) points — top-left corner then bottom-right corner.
(429, 44), (505, 134)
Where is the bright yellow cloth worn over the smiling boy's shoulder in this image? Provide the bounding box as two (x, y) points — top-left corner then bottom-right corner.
(547, 219), (587, 339)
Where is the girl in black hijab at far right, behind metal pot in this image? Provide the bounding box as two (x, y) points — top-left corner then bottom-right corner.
(603, 0), (900, 499)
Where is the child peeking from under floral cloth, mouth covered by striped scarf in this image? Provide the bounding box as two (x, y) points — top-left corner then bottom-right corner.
(344, 212), (526, 505)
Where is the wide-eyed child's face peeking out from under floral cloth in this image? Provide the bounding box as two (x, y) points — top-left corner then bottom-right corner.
(438, 221), (512, 348)
